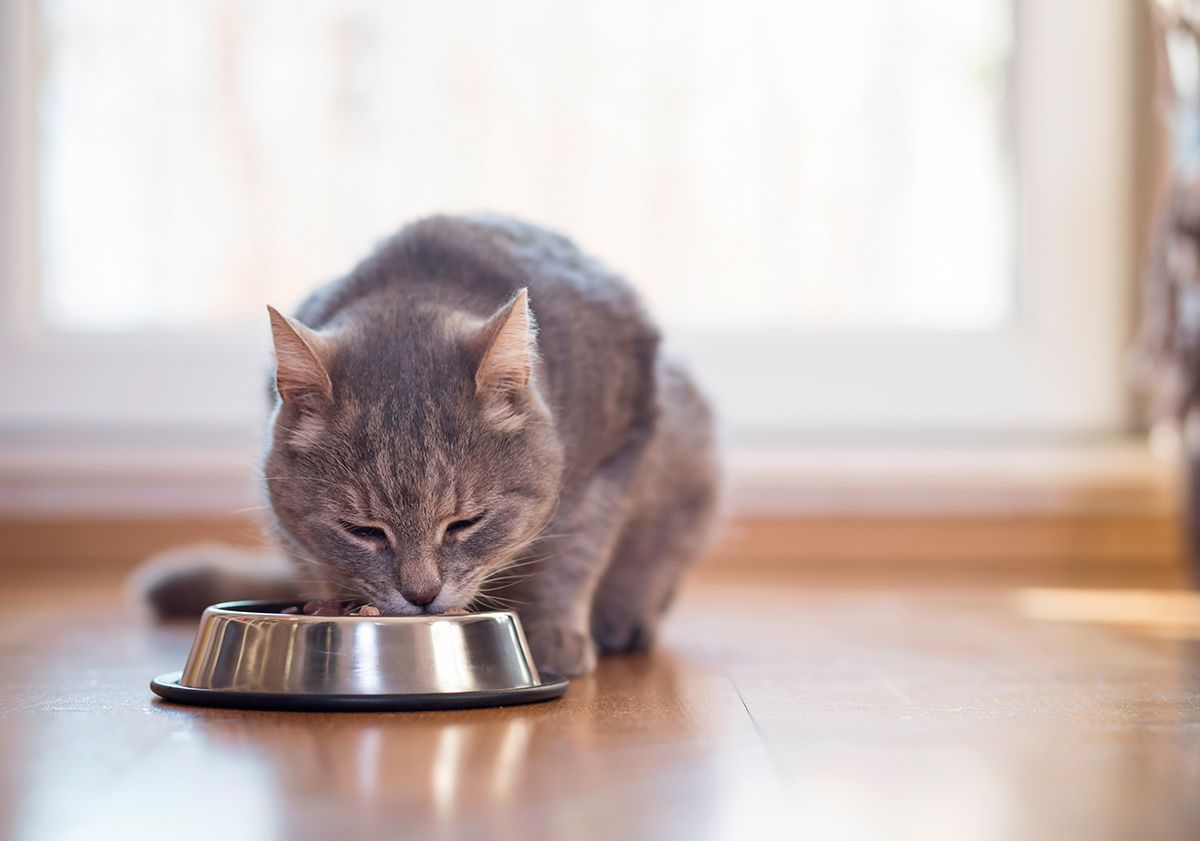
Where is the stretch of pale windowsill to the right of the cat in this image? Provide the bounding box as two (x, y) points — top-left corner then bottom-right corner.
(728, 437), (1177, 516)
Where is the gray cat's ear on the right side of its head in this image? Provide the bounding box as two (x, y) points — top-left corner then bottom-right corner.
(475, 289), (538, 427)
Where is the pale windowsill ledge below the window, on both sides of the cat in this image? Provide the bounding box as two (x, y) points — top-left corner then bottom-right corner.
(0, 438), (1177, 518)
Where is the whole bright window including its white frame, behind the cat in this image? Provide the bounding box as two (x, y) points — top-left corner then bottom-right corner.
(0, 0), (1129, 440)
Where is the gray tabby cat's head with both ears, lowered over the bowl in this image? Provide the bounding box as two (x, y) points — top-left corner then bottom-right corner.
(264, 289), (563, 614)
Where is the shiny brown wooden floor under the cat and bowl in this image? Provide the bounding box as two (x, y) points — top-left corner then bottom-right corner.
(0, 571), (1200, 841)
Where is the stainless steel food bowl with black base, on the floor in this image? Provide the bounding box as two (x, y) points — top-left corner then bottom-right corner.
(151, 601), (566, 709)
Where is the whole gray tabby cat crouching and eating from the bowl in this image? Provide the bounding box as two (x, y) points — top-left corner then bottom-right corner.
(148, 216), (716, 675)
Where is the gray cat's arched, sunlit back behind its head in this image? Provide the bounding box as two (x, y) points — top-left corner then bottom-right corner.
(298, 215), (659, 470)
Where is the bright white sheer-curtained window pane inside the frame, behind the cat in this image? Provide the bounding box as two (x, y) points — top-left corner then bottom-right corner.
(37, 0), (1014, 331)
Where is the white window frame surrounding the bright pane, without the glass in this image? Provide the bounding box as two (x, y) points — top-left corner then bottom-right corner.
(0, 0), (1134, 444)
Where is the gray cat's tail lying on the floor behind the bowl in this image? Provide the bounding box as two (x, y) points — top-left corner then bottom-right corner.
(127, 543), (302, 619)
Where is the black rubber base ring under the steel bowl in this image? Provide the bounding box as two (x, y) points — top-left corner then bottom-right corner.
(150, 672), (570, 713)
